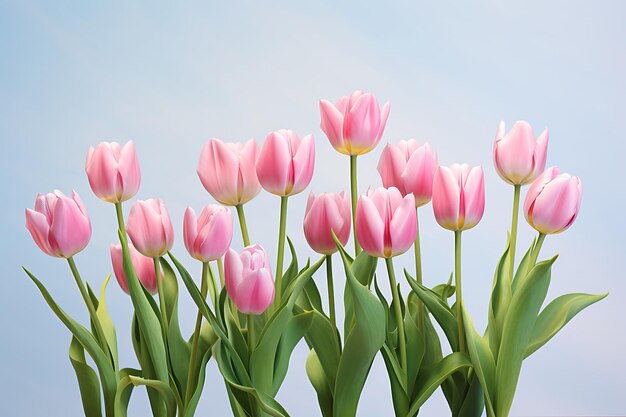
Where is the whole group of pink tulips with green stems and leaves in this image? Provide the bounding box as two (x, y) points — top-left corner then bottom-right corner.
(25, 91), (606, 417)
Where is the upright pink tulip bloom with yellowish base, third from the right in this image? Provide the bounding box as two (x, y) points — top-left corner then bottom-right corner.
(433, 164), (485, 231)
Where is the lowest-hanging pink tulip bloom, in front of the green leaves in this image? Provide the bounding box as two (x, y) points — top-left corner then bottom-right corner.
(224, 245), (274, 314)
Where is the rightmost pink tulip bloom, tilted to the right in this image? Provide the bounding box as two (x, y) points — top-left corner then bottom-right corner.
(524, 167), (583, 234)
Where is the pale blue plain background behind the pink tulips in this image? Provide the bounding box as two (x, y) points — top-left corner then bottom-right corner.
(0, 0), (626, 417)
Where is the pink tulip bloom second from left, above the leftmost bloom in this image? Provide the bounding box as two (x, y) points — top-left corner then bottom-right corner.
(85, 141), (141, 203)
